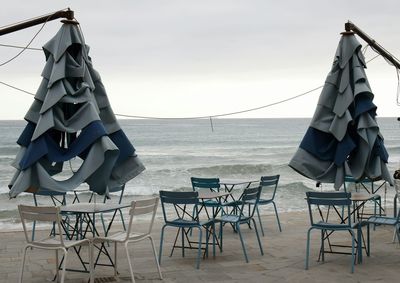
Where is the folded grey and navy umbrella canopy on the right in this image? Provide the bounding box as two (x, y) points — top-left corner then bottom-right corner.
(289, 33), (392, 190)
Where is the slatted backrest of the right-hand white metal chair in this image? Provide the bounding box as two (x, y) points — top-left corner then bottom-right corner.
(126, 197), (159, 241)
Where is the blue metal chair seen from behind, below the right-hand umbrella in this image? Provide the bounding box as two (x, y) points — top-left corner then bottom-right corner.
(305, 192), (361, 273)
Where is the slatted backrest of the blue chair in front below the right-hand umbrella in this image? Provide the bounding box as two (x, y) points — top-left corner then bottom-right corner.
(306, 192), (351, 227)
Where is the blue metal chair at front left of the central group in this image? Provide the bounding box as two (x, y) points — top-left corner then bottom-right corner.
(158, 191), (215, 269)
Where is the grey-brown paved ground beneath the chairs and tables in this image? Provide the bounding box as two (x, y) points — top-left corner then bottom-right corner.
(0, 211), (400, 283)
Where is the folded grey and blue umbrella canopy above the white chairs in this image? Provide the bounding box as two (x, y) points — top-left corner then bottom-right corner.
(9, 23), (145, 197)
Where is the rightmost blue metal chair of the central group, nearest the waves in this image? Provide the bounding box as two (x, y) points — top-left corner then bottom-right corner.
(257, 175), (282, 236)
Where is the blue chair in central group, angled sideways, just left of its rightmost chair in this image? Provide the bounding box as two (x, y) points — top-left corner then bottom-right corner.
(215, 187), (264, 262)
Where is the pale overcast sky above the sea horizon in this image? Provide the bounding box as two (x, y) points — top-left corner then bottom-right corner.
(0, 0), (400, 119)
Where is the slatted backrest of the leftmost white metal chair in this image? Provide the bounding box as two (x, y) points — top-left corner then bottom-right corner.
(18, 205), (64, 246)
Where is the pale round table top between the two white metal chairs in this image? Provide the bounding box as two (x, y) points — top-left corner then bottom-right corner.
(61, 202), (131, 213)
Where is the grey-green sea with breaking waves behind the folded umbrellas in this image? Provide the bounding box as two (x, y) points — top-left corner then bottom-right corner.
(0, 118), (400, 229)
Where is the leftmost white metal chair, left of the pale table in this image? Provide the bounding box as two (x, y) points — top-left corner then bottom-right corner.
(18, 205), (93, 283)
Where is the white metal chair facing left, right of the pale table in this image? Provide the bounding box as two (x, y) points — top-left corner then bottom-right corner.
(92, 197), (162, 282)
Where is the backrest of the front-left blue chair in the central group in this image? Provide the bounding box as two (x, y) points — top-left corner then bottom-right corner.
(160, 191), (199, 223)
